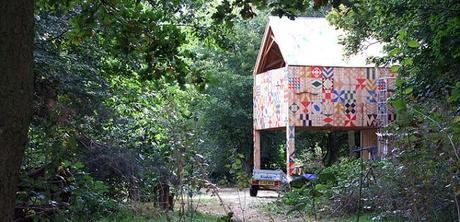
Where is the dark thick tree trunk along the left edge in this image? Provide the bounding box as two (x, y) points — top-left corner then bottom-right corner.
(0, 0), (34, 221)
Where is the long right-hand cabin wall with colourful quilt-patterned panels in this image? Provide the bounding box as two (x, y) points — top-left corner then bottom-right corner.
(287, 66), (391, 130)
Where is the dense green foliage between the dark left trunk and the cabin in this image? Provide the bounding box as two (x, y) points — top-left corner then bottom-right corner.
(16, 1), (294, 220)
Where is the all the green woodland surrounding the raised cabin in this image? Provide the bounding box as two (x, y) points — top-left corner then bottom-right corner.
(0, 0), (460, 221)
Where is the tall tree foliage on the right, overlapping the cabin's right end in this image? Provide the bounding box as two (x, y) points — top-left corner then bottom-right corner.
(329, 0), (460, 219)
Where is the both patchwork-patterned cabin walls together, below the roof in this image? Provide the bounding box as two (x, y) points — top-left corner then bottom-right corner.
(254, 66), (395, 130)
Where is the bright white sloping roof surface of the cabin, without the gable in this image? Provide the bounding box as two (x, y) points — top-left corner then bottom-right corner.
(268, 17), (383, 67)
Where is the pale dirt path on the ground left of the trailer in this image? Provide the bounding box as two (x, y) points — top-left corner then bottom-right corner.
(195, 188), (303, 222)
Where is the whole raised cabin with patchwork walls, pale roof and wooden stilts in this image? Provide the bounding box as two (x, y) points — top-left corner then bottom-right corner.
(253, 17), (395, 175)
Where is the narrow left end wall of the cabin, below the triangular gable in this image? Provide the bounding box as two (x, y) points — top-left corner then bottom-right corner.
(253, 67), (288, 130)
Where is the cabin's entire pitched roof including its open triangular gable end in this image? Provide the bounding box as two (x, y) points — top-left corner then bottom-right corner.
(254, 17), (384, 71)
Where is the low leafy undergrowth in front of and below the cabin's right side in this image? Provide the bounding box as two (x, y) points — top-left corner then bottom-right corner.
(264, 157), (454, 221)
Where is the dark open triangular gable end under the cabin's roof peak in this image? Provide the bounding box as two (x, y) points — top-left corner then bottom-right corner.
(254, 23), (286, 74)
